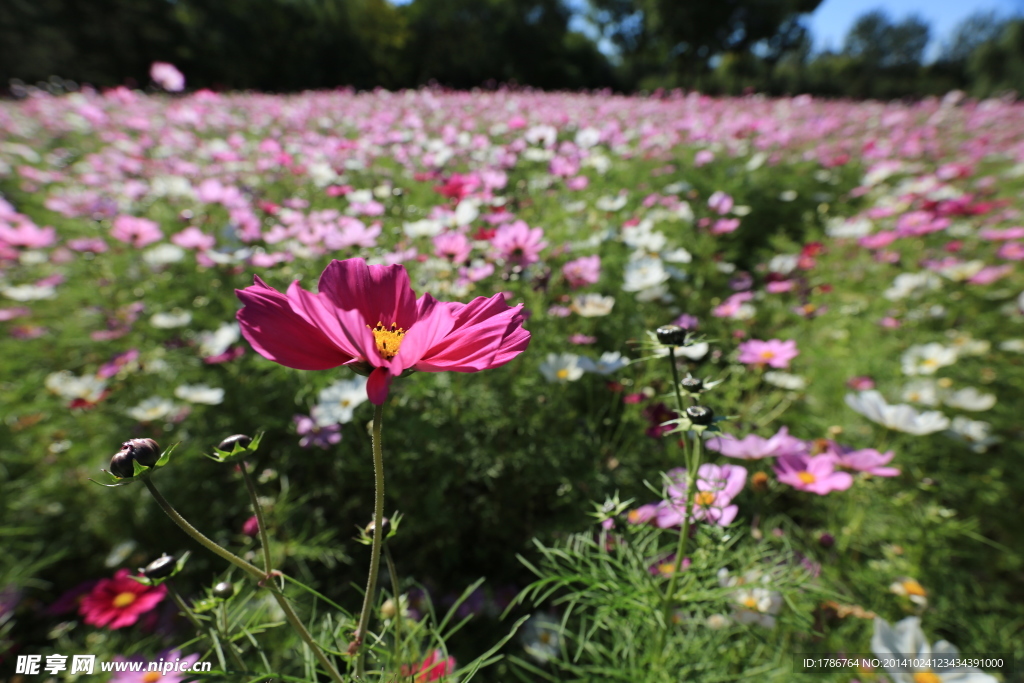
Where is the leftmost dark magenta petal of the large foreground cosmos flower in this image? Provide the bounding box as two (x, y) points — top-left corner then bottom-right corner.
(236, 278), (352, 370)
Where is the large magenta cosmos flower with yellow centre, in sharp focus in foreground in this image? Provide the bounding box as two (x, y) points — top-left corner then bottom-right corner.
(236, 258), (529, 405)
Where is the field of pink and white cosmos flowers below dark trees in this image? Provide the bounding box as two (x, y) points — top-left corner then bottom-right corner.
(0, 88), (1024, 683)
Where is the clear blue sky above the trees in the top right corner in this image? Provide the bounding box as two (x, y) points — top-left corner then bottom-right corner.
(808, 0), (1024, 53)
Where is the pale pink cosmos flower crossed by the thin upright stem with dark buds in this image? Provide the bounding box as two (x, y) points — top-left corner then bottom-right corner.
(655, 463), (746, 528)
